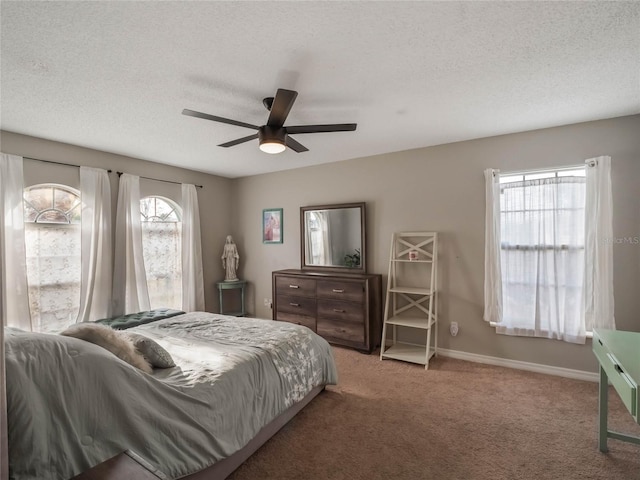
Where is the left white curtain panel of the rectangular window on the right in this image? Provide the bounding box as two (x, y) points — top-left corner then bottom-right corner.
(483, 168), (502, 323)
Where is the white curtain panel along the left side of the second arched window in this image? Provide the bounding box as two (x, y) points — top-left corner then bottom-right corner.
(112, 173), (150, 315)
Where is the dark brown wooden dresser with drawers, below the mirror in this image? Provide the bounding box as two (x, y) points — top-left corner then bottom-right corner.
(272, 270), (382, 353)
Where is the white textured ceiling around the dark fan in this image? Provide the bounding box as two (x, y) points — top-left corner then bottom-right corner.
(0, 0), (640, 177)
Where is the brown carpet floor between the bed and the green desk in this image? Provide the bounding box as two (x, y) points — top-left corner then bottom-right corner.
(229, 347), (640, 480)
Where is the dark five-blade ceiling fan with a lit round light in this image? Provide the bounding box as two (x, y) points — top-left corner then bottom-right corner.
(182, 88), (357, 153)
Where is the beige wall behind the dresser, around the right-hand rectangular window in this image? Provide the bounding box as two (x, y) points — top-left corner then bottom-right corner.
(232, 115), (640, 371)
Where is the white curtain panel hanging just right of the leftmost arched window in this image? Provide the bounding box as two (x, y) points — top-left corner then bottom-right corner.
(77, 167), (113, 322)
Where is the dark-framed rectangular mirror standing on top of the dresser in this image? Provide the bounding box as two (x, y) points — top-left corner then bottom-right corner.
(300, 202), (366, 273)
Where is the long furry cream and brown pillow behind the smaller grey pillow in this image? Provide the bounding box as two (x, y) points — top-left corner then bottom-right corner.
(60, 323), (153, 373)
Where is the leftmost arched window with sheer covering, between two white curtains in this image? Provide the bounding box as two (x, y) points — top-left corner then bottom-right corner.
(24, 184), (82, 332)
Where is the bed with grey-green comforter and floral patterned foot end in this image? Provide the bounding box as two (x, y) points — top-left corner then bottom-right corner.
(5, 312), (337, 480)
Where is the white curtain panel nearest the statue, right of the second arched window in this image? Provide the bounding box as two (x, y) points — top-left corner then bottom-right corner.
(182, 184), (204, 312)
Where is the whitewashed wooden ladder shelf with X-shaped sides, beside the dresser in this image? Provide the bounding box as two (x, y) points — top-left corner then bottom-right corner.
(380, 232), (438, 369)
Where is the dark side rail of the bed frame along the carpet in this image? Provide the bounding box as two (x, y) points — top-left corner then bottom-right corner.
(180, 385), (325, 480)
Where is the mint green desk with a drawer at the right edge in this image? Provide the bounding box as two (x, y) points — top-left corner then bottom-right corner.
(593, 329), (640, 452)
